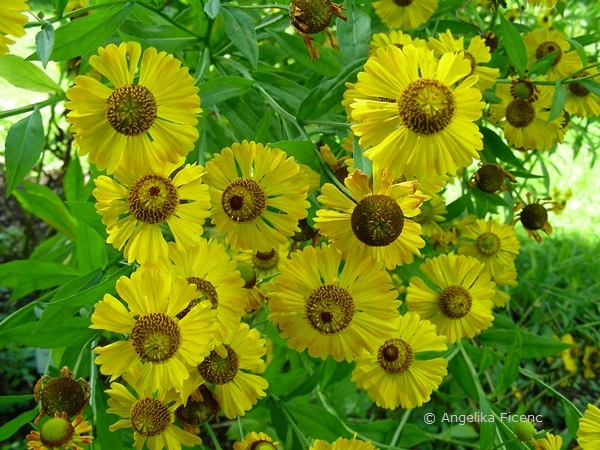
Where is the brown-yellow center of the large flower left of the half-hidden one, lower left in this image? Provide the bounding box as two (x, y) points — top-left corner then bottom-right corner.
(131, 312), (181, 363)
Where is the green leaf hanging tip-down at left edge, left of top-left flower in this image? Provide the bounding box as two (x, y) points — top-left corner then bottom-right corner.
(0, 108), (44, 198)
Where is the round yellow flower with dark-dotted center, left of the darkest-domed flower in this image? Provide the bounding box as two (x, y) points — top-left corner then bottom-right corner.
(204, 141), (310, 252)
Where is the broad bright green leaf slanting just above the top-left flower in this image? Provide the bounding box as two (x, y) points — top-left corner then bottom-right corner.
(50, 3), (133, 61)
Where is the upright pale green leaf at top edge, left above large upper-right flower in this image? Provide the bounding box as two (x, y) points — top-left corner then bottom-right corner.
(337, 0), (371, 61)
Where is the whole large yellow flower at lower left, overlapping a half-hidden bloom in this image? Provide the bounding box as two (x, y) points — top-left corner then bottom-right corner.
(90, 269), (216, 390)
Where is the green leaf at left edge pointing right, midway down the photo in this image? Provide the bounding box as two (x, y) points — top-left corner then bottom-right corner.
(0, 260), (79, 298)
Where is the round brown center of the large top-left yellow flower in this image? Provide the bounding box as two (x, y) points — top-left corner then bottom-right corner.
(104, 84), (157, 136)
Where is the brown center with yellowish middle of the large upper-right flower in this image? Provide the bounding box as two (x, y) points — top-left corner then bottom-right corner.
(398, 78), (456, 136)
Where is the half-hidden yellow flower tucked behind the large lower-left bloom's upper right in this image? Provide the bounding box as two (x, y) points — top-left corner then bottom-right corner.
(168, 239), (247, 345)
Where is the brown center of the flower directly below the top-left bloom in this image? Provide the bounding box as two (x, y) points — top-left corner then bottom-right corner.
(127, 175), (179, 225)
